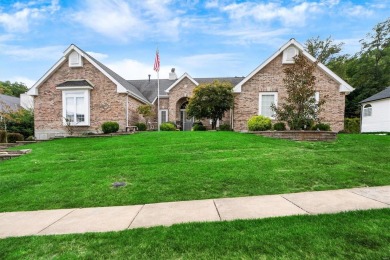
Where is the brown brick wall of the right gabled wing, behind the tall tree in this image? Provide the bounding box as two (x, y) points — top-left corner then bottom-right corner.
(234, 53), (345, 132)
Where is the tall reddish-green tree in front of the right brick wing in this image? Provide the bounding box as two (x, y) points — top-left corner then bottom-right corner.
(272, 53), (326, 130)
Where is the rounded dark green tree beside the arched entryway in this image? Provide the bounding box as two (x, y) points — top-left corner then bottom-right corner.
(187, 80), (234, 129)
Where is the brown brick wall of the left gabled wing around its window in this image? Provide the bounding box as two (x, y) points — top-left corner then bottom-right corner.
(34, 59), (142, 139)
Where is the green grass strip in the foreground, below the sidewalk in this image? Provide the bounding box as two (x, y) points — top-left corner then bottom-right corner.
(0, 209), (390, 260)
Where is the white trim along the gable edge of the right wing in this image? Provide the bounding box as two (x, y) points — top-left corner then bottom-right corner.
(233, 39), (354, 93)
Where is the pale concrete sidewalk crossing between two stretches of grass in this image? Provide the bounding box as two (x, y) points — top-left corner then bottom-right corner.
(0, 186), (390, 238)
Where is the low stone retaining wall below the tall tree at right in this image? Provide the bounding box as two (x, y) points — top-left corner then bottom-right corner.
(249, 131), (337, 141)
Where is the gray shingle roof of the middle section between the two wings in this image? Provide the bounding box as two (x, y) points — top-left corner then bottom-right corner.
(128, 77), (244, 102)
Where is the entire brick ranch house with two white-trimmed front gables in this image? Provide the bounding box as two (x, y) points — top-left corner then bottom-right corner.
(27, 39), (354, 139)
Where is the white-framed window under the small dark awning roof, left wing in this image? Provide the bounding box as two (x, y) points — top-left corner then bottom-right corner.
(62, 89), (90, 126)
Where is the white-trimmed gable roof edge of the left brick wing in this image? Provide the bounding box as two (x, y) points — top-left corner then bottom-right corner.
(27, 44), (149, 103)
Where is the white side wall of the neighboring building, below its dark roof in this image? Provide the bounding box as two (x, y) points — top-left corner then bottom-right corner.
(361, 98), (390, 133)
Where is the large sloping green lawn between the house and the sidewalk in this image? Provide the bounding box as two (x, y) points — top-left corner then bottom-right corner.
(0, 132), (390, 211)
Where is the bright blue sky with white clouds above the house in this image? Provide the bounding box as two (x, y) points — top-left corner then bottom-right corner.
(0, 0), (390, 87)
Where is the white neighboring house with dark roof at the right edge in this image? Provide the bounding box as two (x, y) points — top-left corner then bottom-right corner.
(360, 87), (390, 133)
